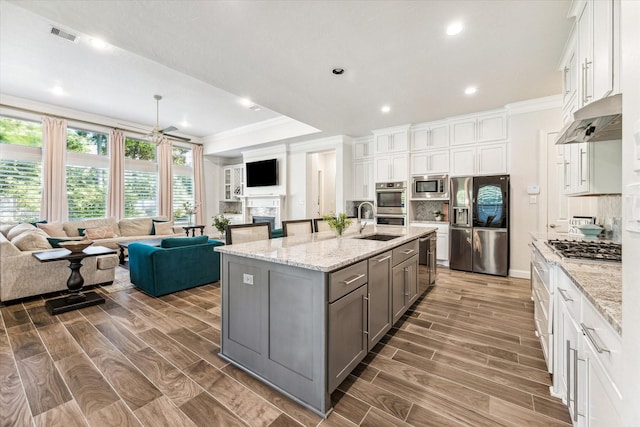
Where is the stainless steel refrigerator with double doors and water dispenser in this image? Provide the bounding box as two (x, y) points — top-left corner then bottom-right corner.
(449, 175), (509, 276)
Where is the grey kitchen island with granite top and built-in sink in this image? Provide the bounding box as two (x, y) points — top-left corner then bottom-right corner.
(216, 226), (435, 416)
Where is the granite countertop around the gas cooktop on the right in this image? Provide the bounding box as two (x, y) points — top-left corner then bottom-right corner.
(532, 233), (622, 335)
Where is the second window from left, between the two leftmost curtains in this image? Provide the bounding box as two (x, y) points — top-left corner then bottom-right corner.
(67, 128), (109, 220)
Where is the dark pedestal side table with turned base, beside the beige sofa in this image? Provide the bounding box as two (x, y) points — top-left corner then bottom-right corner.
(33, 246), (116, 314)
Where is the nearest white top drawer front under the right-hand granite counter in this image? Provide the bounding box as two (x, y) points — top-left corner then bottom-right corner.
(580, 301), (622, 390)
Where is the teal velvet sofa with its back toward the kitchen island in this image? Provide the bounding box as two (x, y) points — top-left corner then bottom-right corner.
(129, 236), (224, 296)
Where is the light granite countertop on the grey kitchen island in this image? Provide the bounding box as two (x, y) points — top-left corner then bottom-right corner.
(215, 226), (437, 272)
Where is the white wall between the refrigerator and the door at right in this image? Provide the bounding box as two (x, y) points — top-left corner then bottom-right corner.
(509, 104), (562, 278)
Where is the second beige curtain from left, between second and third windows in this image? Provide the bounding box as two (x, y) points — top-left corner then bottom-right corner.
(107, 129), (125, 221)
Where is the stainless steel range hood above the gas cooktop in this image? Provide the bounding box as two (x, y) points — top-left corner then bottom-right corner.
(556, 93), (622, 144)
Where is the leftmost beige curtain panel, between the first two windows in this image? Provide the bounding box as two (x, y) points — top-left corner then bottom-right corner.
(40, 116), (69, 222)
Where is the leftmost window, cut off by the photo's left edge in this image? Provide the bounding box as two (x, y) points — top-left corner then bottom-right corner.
(0, 117), (42, 222)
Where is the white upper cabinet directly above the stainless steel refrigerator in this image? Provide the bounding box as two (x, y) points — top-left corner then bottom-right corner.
(449, 112), (507, 145)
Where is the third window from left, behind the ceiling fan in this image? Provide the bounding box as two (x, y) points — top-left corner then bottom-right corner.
(124, 138), (158, 218)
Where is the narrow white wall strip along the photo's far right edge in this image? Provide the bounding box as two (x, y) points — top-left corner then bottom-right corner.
(620, 0), (640, 427)
